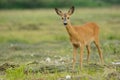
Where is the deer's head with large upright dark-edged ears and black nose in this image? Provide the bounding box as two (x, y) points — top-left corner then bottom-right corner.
(55, 6), (74, 25)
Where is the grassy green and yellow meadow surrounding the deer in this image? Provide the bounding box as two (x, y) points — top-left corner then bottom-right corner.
(0, 7), (120, 80)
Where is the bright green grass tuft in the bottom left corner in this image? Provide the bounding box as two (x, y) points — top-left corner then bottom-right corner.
(6, 66), (26, 80)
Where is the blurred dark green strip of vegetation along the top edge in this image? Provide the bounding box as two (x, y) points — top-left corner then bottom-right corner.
(0, 0), (120, 9)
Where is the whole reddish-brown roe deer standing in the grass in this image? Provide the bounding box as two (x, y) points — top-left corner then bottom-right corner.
(55, 6), (103, 70)
